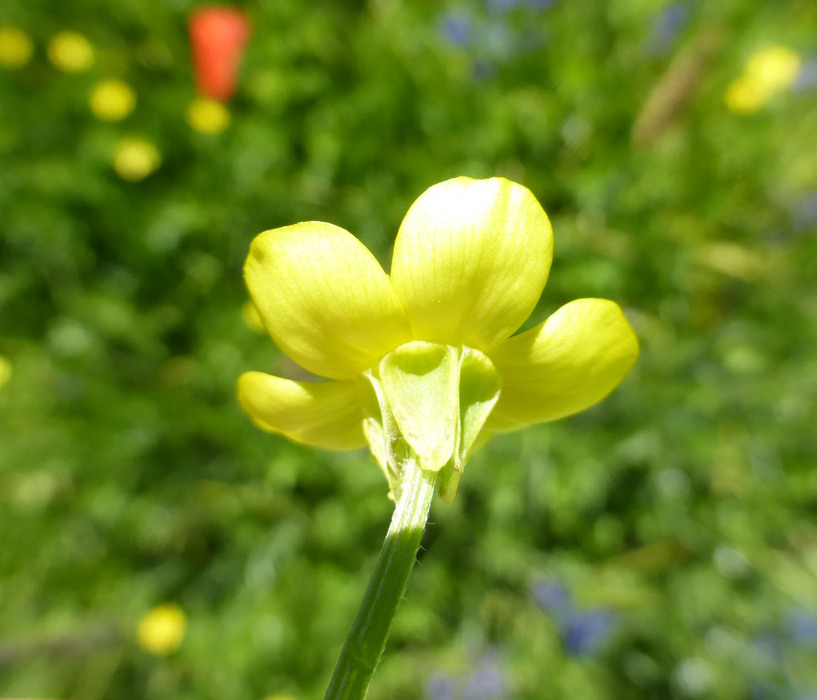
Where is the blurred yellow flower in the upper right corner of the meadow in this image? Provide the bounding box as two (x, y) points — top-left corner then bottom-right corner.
(724, 46), (802, 114)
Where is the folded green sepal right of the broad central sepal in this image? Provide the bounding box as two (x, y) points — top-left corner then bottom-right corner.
(437, 347), (501, 503)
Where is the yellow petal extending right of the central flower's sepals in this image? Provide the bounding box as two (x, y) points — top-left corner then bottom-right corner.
(488, 299), (638, 432)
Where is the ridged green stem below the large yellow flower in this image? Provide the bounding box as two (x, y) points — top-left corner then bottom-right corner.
(324, 459), (437, 700)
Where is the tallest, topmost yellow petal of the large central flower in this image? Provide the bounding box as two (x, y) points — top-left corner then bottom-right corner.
(391, 177), (553, 352)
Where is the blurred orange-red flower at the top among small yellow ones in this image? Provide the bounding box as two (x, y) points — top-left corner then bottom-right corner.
(189, 6), (250, 101)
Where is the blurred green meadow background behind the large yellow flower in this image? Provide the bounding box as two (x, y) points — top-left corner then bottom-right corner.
(0, 0), (817, 700)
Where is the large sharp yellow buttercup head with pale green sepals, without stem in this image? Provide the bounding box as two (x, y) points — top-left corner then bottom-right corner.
(238, 177), (638, 500)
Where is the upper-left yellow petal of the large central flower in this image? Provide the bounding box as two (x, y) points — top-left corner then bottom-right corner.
(244, 222), (411, 379)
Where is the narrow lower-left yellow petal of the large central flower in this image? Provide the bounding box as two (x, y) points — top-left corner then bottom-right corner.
(238, 372), (366, 450)
